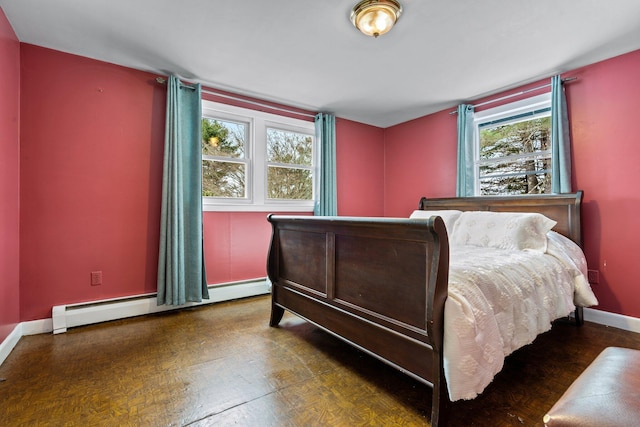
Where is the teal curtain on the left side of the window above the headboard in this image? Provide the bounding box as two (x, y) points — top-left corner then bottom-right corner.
(456, 104), (476, 197)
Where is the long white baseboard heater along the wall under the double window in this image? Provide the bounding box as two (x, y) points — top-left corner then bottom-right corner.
(52, 278), (271, 334)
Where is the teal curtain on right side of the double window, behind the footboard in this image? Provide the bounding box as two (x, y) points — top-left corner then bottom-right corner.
(313, 113), (338, 216)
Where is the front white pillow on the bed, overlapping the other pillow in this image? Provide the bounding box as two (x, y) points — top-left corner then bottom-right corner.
(451, 211), (556, 252)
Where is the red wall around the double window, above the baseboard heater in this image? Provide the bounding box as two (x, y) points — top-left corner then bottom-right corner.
(20, 44), (384, 321)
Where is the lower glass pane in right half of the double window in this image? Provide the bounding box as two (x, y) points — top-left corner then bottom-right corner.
(267, 166), (313, 200)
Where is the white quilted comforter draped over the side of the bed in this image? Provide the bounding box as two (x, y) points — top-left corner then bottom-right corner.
(444, 236), (597, 401)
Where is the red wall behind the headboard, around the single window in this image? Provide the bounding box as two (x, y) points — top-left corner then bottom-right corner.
(384, 51), (640, 317)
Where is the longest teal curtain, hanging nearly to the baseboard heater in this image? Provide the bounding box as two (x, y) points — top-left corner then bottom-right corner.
(158, 76), (209, 305)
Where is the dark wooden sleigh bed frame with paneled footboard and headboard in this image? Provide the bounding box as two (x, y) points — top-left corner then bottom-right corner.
(267, 192), (582, 427)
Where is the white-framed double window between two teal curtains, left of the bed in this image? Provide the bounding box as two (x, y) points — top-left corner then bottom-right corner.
(201, 101), (317, 211)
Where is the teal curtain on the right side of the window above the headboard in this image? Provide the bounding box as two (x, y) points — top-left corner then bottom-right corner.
(551, 76), (571, 193)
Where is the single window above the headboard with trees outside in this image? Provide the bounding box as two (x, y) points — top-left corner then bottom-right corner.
(474, 93), (551, 195)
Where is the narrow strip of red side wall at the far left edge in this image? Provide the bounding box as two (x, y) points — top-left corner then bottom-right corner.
(0, 9), (20, 342)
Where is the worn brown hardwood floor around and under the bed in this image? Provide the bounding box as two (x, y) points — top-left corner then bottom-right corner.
(0, 296), (640, 427)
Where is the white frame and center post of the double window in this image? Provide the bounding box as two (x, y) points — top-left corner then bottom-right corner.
(202, 99), (319, 212)
